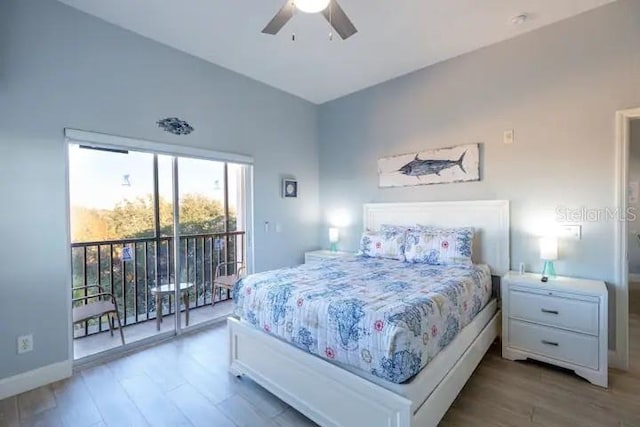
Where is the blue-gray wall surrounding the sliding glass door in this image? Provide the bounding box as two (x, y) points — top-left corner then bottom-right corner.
(0, 0), (318, 379)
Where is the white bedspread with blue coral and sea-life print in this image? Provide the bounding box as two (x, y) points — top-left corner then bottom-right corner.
(233, 256), (491, 383)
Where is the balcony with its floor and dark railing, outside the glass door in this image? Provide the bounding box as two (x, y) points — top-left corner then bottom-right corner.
(71, 231), (246, 359)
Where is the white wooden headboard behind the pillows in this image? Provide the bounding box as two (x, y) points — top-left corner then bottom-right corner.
(364, 200), (511, 275)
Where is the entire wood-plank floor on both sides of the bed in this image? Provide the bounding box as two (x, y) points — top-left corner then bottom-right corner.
(0, 292), (640, 427)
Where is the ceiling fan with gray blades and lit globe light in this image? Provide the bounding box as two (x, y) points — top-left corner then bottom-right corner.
(262, 0), (358, 40)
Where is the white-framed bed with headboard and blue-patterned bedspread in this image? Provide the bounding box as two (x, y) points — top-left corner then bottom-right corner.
(228, 201), (509, 427)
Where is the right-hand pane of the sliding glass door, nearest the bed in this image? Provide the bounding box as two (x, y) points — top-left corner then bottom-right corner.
(177, 157), (246, 326)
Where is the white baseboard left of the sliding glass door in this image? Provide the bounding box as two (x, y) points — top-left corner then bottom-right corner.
(0, 360), (73, 400)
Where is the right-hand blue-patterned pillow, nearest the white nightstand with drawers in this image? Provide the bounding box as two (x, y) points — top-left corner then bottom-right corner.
(404, 227), (474, 265)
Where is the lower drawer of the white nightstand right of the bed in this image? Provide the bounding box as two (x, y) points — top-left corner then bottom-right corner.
(509, 319), (599, 369)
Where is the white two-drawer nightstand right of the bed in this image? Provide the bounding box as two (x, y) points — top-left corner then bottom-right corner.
(501, 272), (608, 387)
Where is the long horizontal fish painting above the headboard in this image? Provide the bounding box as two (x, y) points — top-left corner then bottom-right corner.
(378, 144), (480, 188)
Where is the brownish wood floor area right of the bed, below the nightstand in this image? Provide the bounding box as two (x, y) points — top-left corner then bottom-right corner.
(440, 291), (640, 427)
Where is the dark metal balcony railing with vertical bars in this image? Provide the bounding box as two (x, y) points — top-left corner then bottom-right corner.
(71, 231), (245, 338)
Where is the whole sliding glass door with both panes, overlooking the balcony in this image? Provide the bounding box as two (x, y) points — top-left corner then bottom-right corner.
(69, 144), (248, 359)
